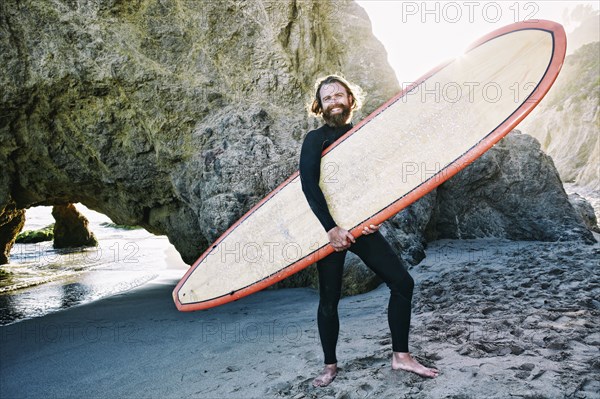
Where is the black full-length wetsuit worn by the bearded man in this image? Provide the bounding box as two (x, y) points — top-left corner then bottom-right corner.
(300, 124), (414, 364)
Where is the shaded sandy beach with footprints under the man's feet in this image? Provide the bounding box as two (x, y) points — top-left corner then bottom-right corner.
(0, 235), (600, 399)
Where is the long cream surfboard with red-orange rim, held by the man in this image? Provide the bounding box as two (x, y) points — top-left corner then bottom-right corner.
(173, 20), (566, 311)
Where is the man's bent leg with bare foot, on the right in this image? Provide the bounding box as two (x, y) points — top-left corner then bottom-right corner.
(350, 232), (437, 377)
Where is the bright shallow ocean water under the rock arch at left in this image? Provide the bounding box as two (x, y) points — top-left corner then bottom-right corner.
(0, 204), (188, 325)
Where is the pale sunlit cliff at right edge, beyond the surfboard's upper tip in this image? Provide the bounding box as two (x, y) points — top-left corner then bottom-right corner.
(520, 42), (600, 190)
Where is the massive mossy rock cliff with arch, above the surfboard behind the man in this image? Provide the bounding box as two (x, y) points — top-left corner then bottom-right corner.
(0, 0), (399, 262)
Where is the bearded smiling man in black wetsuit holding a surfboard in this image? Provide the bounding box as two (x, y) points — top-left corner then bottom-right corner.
(300, 75), (438, 387)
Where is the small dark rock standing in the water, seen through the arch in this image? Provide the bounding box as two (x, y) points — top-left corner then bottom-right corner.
(52, 204), (98, 248)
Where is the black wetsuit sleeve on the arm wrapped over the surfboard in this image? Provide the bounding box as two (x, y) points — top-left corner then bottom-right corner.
(300, 131), (337, 231)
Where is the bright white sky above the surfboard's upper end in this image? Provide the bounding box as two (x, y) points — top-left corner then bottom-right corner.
(358, 0), (600, 86)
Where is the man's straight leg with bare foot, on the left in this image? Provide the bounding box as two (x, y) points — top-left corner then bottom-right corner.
(313, 251), (346, 387)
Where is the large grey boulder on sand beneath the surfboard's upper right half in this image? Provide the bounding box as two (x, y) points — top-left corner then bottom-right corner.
(427, 131), (595, 243)
